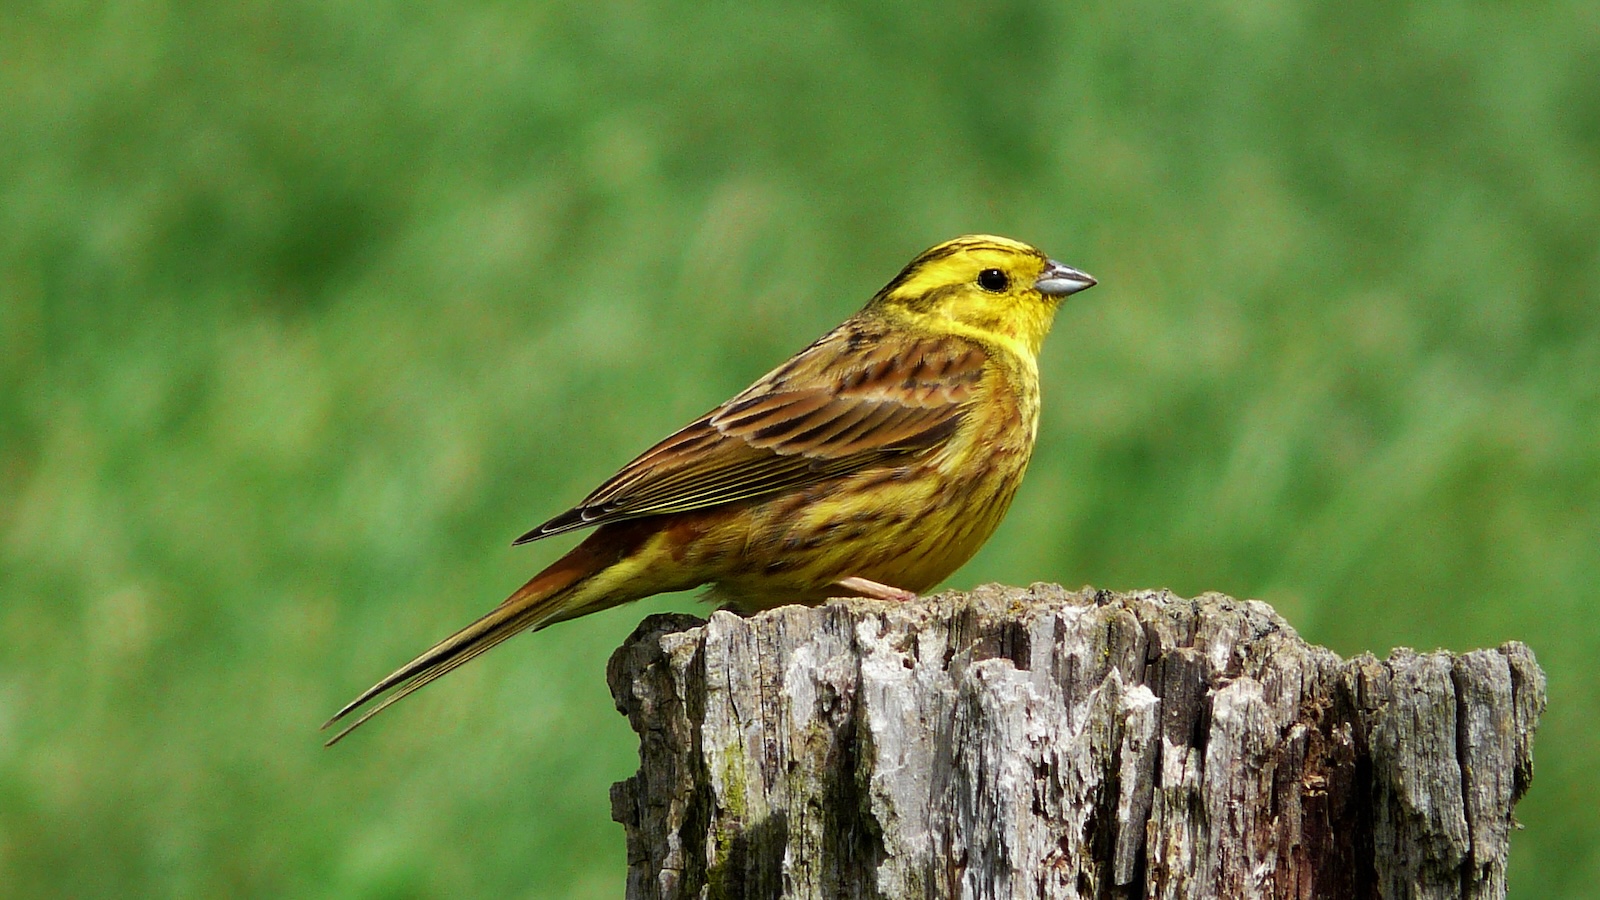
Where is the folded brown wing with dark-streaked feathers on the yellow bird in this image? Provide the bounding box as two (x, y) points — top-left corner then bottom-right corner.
(515, 322), (987, 543)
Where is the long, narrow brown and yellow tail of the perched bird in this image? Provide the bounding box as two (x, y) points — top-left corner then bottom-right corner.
(322, 532), (632, 746)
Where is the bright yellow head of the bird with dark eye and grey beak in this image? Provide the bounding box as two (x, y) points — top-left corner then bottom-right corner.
(867, 234), (1094, 357)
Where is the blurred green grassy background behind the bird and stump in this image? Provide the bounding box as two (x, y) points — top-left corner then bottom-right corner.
(0, 0), (1600, 898)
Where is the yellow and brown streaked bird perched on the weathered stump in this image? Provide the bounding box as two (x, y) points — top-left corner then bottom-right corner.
(323, 234), (1096, 746)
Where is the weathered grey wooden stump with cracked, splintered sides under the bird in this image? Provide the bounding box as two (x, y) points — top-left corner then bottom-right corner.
(610, 585), (1544, 900)
